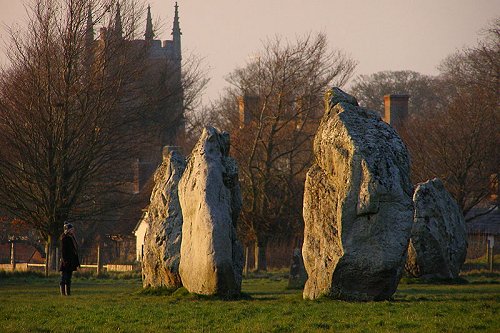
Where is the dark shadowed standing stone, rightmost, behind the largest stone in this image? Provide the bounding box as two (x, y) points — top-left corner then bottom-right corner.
(406, 178), (467, 279)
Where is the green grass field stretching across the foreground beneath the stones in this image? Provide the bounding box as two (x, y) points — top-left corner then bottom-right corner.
(0, 274), (500, 332)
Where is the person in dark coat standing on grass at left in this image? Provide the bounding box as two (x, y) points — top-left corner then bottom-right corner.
(59, 222), (80, 296)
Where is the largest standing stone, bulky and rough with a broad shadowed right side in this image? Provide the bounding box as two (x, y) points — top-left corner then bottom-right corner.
(302, 89), (413, 300)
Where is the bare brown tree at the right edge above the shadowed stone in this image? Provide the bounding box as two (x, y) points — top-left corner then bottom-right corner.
(402, 20), (500, 215)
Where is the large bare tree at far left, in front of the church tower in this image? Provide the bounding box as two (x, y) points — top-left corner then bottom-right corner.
(0, 0), (176, 270)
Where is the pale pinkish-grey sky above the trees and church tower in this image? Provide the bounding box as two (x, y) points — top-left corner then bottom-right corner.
(0, 0), (500, 101)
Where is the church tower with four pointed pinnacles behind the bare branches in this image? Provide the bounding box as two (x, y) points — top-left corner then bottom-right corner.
(86, 2), (184, 160)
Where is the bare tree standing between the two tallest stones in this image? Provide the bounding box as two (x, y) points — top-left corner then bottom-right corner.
(215, 34), (355, 270)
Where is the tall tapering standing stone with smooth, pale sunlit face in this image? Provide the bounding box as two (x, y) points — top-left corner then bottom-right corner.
(179, 127), (243, 296)
